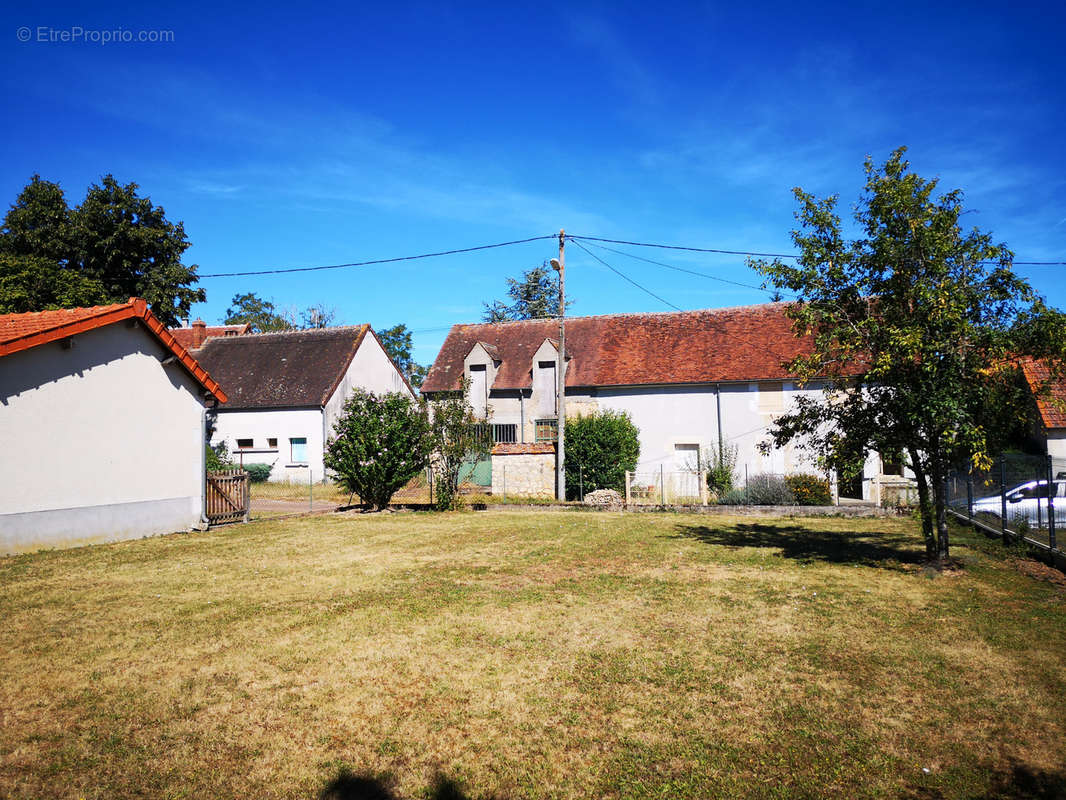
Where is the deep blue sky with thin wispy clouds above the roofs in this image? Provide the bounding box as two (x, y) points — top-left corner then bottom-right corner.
(0, 2), (1066, 363)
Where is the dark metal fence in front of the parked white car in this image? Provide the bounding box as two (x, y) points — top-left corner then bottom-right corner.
(948, 454), (1066, 550)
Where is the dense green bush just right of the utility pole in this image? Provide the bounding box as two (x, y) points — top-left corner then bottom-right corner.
(563, 411), (641, 499)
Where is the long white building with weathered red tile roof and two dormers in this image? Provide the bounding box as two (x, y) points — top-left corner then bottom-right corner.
(422, 303), (895, 500)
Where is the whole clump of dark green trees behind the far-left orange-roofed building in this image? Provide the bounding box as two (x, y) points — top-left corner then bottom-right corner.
(0, 175), (206, 325)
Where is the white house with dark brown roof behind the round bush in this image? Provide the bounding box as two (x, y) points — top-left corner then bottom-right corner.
(194, 325), (415, 483)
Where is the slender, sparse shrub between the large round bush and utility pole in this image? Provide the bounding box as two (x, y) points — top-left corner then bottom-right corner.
(432, 380), (490, 511)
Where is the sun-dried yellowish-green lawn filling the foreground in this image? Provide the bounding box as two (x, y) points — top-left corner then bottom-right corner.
(0, 511), (1066, 800)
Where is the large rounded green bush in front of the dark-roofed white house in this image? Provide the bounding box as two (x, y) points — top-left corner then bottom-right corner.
(324, 389), (434, 510)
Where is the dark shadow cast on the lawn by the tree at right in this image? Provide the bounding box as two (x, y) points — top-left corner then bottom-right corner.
(675, 523), (925, 569)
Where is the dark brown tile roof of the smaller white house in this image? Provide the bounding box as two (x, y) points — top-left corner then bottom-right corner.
(196, 325), (373, 409)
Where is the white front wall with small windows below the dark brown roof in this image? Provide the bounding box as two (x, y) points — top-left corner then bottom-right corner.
(211, 406), (323, 483)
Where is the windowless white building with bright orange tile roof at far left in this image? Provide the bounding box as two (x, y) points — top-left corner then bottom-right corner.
(0, 299), (226, 553)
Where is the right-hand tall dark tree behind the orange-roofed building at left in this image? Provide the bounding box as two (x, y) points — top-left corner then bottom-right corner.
(70, 175), (207, 325)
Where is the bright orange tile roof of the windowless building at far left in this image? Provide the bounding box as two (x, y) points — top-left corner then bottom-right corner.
(0, 298), (226, 402)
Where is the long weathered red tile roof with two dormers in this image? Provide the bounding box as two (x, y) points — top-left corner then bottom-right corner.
(422, 303), (811, 393)
